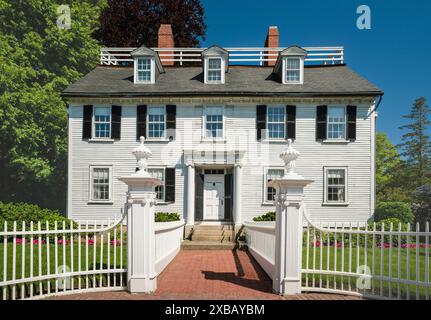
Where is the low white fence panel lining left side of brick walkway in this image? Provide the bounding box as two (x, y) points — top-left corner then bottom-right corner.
(155, 220), (185, 274)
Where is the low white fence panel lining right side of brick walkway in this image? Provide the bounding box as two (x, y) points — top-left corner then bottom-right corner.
(244, 222), (275, 279)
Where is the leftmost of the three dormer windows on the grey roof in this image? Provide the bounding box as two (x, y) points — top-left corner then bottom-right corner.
(131, 46), (165, 84)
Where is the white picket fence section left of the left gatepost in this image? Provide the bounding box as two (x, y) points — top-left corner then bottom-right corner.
(0, 214), (127, 300)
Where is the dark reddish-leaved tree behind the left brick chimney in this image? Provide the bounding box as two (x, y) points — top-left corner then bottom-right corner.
(94, 0), (206, 47)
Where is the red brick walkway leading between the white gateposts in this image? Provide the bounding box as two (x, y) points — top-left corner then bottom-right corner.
(48, 250), (358, 300)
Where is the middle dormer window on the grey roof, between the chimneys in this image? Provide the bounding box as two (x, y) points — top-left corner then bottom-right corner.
(202, 46), (229, 84)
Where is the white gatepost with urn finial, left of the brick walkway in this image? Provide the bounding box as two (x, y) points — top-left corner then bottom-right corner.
(119, 137), (161, 293)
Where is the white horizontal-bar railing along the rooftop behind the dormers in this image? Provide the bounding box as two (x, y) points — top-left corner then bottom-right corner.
(100, 47), (344, 66)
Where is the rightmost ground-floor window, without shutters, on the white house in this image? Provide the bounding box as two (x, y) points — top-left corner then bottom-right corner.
(325, 168), (347, 203)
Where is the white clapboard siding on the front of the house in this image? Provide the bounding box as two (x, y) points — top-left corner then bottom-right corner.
(68, 104), (372, 221)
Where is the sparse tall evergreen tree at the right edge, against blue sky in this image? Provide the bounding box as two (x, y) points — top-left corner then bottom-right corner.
(399, 97), (431, 187)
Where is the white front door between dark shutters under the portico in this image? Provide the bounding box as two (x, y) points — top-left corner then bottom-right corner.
(203, 174), (224, 220)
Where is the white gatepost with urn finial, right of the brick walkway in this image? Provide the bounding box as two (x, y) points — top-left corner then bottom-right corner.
(268, 139), (313, 295)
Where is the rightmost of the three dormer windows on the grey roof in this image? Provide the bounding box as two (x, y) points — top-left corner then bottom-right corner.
(274, 46), (307, 84)
